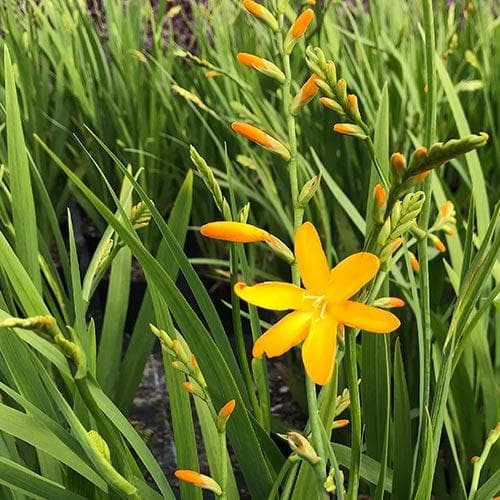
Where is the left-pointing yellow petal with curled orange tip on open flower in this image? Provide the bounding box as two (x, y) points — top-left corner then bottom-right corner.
(234, 281), (306, 311)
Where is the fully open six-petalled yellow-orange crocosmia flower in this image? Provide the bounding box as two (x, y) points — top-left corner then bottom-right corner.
(235, 222), (400, 385)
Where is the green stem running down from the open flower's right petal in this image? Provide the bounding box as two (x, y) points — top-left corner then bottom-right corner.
(345, 328), (361, 500)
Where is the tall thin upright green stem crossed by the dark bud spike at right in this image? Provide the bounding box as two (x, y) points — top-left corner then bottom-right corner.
(417, 0), (437, 484)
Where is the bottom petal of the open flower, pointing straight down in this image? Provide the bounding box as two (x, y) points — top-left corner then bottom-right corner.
(302, 313), (337, 385)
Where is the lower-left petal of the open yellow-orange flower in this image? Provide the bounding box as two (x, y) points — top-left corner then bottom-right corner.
(252, 311), (312, 359)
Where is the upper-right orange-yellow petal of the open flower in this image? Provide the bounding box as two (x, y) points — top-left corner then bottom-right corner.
(327, 252), (380, 302)
